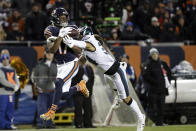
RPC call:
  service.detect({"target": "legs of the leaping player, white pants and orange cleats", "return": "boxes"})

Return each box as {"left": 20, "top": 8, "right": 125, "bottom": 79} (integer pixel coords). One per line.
{"left": 40, "top": 61, "right": 89, "bottom": 120}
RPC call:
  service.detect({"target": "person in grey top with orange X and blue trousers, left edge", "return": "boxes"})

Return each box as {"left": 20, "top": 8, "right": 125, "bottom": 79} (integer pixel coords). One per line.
{"left": 0, "top": 53, "right": 20, "bottom": 130}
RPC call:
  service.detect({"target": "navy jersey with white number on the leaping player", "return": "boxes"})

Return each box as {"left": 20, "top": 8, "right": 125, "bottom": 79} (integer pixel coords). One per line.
{"left": 44, "top": 25, "right": 76, "bottom": 64}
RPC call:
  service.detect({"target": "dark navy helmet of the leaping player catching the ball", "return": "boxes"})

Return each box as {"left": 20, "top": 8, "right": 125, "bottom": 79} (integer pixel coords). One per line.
{"left": 51, "top": 8, "right": 69, "bottom": 27}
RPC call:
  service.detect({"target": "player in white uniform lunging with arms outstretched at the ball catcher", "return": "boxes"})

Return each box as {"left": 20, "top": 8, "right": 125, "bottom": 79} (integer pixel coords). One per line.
{"left": 63, "top": 27, "right": 145, "bottom": 131}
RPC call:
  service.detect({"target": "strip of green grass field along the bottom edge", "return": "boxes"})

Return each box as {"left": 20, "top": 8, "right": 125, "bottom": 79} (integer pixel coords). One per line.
{"left": 18, "top": 125, "right": 196, "bottom": 131}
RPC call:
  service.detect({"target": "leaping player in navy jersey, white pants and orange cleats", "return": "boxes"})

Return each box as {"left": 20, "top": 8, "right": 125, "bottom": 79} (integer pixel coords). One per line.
{"left": 40, "top": 8, "right": 89, "bottom": 120}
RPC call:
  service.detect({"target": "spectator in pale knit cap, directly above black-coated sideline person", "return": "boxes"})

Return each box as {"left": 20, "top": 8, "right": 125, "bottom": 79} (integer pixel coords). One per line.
{"left": 145, "top": 16, "right": 161, "bottom": 41}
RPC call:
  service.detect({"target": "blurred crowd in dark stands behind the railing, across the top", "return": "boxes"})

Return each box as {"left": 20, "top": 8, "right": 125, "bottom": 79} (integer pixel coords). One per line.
{"left": 0, "top": 0, "right": 196, "bottom": 42}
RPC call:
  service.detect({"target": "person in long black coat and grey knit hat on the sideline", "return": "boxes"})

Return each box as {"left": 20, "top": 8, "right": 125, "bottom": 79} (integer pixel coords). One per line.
{"left": 142, "top": 48, "right": 171, "bottom": 126}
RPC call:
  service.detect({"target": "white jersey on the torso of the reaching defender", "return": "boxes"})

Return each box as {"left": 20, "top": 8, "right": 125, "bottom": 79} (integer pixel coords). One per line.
{"left": 82, "top": 35, "right": 115, "bottom": 71}
